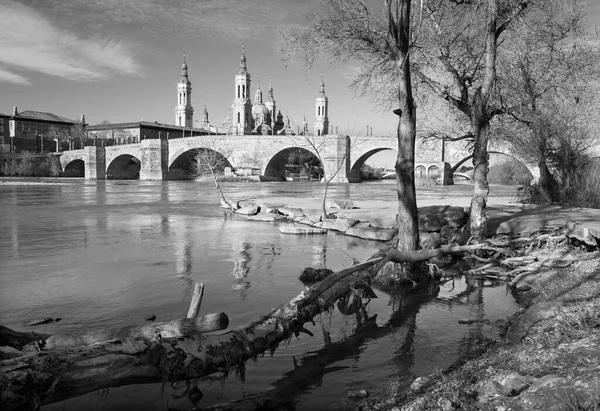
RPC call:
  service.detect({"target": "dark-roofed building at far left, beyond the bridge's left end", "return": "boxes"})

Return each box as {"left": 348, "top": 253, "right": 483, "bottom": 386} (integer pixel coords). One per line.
{"left": 0, "top": 107, "right": 87, "bottom": 153}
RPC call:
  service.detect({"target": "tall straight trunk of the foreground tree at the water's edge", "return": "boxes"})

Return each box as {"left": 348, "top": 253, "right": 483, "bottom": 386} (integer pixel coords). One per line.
{"left": 395, "top": 0, "right": 419, "bottom": 251}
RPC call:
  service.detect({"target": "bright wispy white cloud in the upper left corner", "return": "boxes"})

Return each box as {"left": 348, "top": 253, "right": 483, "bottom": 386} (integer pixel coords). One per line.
{"left": 0, "top": 1, "right": 139, "bottom": 84}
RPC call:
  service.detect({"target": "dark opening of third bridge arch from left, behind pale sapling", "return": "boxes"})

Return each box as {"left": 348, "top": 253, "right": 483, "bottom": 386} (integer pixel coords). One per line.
{"left": 169, "top": 147, "right": 233, "bottom": 180}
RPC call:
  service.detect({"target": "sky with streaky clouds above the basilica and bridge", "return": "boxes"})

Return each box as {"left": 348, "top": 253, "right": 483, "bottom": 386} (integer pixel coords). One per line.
{"left": 0, "top": 0, "right": 600, "bottom": 142}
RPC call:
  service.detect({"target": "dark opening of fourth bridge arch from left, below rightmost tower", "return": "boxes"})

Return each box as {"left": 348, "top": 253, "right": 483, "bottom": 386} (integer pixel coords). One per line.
{"left": 261, "top": 147, "right": 324, "bottom": 181}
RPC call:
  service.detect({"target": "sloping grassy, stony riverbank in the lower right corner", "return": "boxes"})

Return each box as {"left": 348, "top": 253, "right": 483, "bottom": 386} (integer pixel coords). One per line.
{"left": 358, "top": 246, "right": 600, "bottom": 411}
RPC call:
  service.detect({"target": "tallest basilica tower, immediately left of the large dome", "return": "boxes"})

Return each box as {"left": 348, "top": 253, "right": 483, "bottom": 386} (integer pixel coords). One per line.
{"left": 231, "top": 45, "right": 254, "bottom": 134}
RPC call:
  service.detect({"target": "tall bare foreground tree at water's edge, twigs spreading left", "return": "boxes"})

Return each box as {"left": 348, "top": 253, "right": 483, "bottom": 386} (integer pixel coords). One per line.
{"left": 283, "top": 0, "right": 419, "bottom": 250}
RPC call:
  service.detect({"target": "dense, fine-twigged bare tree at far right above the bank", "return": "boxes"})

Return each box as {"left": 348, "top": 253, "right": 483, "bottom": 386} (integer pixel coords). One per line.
{"left": 499, "top": 0, "right": 600, "bottom": 201}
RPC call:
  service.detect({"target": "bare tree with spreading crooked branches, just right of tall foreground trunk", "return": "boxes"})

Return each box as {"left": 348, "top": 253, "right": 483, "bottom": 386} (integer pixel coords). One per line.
{"left": 417, "top": 0, "right": 535, "bottom": 238}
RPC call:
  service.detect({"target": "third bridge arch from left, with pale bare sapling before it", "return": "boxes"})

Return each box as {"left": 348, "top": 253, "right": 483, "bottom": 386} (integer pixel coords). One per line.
{"left": 169, "top": 147, "right": 232, "bottom": 180}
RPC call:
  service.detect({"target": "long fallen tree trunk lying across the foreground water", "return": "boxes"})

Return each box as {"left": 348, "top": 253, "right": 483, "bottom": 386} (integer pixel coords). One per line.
{"left": 0, "top": 244, "right": 536, "bottom": 410}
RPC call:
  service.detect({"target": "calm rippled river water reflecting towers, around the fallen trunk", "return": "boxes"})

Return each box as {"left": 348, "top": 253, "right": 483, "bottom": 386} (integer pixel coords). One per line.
{"left": 0, "top": 180, "right": 517, "bottom": 411}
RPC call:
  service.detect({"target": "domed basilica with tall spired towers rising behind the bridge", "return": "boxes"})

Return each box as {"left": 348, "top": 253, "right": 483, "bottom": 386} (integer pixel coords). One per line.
{"left": 175, "top": 46, "right": 329, "bottom": 135}
